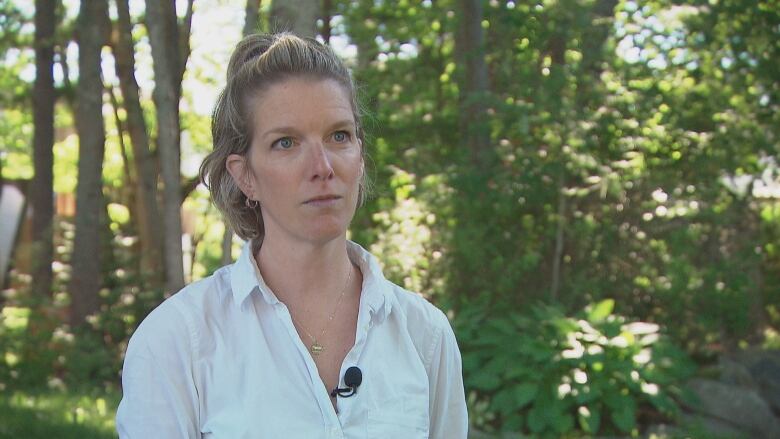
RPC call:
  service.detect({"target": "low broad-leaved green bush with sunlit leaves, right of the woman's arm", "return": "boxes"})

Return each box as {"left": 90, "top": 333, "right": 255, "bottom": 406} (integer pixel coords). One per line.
{"left": 455, "top": 299, "right": 694, "bottom": 436}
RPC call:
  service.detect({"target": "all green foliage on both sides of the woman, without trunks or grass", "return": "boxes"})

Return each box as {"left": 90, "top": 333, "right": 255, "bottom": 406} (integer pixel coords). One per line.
{"left": 0, "top": 0, "right": 780, "bottom": 436}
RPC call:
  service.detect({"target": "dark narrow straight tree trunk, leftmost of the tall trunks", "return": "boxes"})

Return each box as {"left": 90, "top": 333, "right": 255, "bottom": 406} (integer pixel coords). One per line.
{"left": 30, "top": 0, "right": 56, "bottom": 296}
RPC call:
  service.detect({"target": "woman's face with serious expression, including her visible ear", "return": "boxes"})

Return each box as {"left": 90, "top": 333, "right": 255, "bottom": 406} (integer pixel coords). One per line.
{"left": 227, "top": 78, "right": 363, "bottom": 243}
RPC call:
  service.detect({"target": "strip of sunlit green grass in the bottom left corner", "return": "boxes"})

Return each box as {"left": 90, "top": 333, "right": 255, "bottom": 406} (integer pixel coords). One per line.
{"left": 0, "top": 391, "right": 120, "bottom": 439}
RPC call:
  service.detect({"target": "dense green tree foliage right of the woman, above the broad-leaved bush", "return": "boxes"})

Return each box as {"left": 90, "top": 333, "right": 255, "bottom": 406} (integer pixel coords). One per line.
{"left": 337, "top": 1, "right": 780, "bottom": 361}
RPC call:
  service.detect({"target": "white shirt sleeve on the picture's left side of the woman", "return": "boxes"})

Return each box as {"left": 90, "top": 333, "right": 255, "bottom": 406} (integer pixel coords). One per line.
{"left": 116, "top": 296, "right": 200, "bottom": 439}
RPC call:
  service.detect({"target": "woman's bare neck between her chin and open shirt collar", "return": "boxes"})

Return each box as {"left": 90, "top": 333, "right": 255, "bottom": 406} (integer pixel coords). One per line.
{"left": 255, "top": 235, "right": 352, "bottom": 308}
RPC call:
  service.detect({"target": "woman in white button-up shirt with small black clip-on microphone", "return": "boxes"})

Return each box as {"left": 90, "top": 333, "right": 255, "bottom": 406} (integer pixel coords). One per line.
{"left": 117, "top": 33, "right": 468, "bottom": 439}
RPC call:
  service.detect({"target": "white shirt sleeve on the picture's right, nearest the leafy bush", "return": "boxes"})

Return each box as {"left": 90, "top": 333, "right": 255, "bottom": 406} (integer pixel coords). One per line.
{"left": 428, "top": 312, "right": 469, "bottom": 439}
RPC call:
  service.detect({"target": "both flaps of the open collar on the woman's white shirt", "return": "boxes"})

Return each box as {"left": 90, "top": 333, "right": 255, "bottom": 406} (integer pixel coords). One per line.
{"left": 230, "top": 241, "right": 392, "bottom": 321}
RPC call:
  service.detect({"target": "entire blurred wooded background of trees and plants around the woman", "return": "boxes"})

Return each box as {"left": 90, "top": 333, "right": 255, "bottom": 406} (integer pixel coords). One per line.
{"left": 0, "top": 0, "right": 780, "bottom": 438}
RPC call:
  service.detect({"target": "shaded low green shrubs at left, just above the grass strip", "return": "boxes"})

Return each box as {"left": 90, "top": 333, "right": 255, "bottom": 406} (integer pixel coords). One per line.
{"left": 0, "top": 219, "right": 164, "bottom": 390}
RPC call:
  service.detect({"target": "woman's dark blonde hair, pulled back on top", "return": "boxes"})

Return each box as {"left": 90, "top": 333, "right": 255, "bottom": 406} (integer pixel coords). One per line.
{"left": 199, "top": 32, "right": 368, "bottom": 240}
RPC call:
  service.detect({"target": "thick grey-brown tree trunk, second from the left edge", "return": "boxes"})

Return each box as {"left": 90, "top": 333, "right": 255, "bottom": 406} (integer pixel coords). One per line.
{"left": 70, "top": 0, "right": 108, "bottom": 327}
